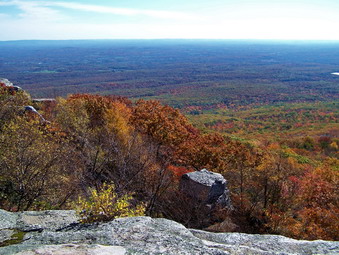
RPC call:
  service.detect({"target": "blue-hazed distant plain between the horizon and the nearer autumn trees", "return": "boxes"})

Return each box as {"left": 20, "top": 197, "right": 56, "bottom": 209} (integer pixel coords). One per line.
{"left": 0, "top": 40, "right": 339, "bottom": 109}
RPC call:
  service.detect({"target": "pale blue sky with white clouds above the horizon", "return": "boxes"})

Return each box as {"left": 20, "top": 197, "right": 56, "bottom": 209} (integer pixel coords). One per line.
{"left": 0, "top": 0, "right": 339, "bottom": 41}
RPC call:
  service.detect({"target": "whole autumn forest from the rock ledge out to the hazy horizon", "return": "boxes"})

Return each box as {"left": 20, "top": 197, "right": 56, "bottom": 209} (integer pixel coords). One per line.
{"left": 0, "top": 41, "right": 339, "bottom": 240}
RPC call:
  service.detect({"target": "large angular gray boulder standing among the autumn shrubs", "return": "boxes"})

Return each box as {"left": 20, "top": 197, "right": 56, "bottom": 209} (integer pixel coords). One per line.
{"left": 180, "top": 169, "right": 232, "bottom": 208}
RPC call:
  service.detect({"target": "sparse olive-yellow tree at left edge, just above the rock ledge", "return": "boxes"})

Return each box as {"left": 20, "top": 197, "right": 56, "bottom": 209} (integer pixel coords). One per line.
{"left": 0, "top": 117, "right": 68, "bottom": 211}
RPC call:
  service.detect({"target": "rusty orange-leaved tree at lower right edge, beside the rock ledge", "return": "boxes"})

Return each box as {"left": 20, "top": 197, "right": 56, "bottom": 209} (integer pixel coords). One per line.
{"left": 287, "top": 160, "right": 339, "bottom": 240}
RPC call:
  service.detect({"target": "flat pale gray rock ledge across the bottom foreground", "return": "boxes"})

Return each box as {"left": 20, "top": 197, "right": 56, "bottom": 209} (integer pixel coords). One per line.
{"left": 0, "top": 210, "right": 339, "bottom": 255}
